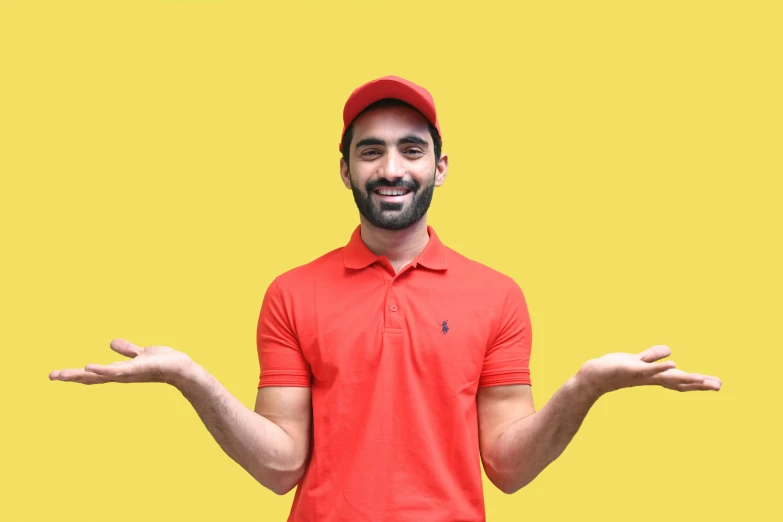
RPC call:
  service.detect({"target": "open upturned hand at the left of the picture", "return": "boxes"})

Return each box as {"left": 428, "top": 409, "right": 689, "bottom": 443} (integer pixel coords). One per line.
{"left": 49, "top": 339, "right": 193, "bottom": 386}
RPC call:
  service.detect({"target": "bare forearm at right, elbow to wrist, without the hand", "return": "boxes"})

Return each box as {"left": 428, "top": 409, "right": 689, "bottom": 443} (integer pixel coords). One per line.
{"left": 484, "top": 374, "right": 600, "bottom": 493}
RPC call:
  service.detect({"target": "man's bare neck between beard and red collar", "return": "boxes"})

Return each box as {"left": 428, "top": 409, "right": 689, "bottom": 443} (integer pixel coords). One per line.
{"left": 361, "top": 215, "right": 430, "bottom": 271}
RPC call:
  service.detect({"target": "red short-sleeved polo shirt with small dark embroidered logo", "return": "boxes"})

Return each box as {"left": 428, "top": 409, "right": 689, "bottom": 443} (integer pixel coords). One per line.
{"left": 257, "top": 227, "right": 531, "bottom": 522}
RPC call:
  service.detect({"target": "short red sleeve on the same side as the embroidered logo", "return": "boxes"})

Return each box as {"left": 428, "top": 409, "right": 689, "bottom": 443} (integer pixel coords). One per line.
{"left": 479, "top": 282, "right": 532, "bottom": 386}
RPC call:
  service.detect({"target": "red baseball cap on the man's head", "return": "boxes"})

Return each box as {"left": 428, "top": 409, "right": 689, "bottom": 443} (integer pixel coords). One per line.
{"left": 339, "top": 76, "right": 441, "bottom": 151}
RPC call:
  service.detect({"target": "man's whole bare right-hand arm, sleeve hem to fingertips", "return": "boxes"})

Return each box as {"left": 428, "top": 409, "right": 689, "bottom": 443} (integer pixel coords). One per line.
{"left": 477, "top": 346, "right": 721, "bottom": 494}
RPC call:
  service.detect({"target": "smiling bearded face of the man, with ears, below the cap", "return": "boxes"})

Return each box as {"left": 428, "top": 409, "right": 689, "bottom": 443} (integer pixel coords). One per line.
{"left": 340, "top": 106, "right": 448, "bottom": 230}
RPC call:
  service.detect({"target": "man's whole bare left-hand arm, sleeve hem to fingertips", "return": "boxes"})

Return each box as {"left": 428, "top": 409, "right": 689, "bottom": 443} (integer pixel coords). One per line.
{"left": 49, "top": 340, "right": 312, "bottom": 495}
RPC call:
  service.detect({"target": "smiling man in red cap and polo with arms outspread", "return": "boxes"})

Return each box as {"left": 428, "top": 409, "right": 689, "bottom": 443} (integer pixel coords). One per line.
{"left": 50, "top": 77, "right": 721, "bottom": 522}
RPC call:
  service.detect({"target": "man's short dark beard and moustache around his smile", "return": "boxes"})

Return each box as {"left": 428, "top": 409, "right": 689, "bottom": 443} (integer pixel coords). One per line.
{"left": 351, "top": 173, "right": 435, "bottom": 230}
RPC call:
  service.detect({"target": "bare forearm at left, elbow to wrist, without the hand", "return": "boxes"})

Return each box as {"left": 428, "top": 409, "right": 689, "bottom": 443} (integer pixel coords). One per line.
{"left": 171, "top": 363, "right": 307, "bottom": 494}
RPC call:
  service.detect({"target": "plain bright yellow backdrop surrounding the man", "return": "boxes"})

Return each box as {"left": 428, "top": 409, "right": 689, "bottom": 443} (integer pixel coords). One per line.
{"left": 0, "top": 0, "right": 783, "bottom": 522}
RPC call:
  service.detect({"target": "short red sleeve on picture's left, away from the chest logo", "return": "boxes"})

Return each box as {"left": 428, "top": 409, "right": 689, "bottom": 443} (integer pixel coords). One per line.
{"left": 256, "top": 280, "right": 311, "bottom": 388}
